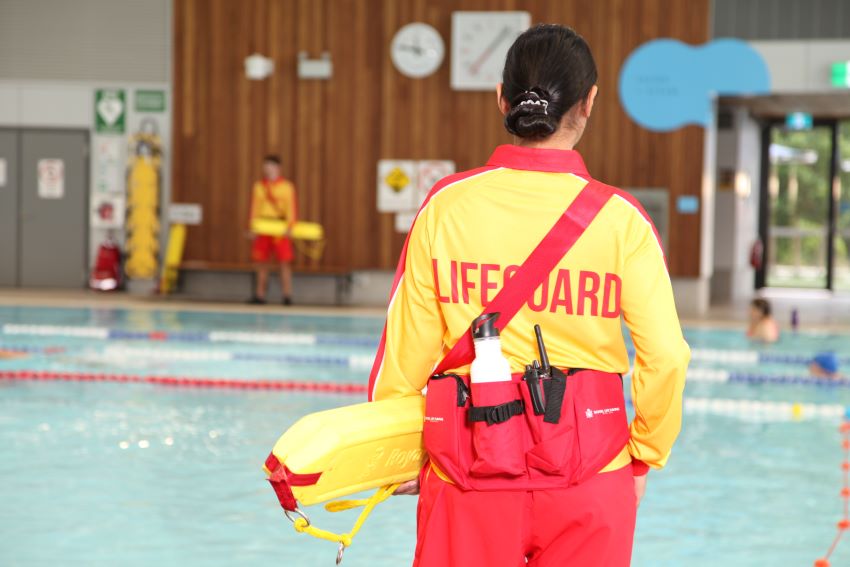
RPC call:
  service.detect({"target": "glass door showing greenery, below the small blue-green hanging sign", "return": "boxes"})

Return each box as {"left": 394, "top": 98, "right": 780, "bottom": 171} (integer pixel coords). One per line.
{"left": 762, "top": 124, "right": 828, "bottom": 288}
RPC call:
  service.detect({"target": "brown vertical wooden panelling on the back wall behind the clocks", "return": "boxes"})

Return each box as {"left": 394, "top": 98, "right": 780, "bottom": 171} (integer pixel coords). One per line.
{"left": 172, "top": 0, "right": 709, "bottom": 276}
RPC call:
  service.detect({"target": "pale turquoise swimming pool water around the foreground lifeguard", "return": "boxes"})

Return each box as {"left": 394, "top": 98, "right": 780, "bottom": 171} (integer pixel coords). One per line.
{"left": 0, "top": 307, "right": 850, "bottom": 567}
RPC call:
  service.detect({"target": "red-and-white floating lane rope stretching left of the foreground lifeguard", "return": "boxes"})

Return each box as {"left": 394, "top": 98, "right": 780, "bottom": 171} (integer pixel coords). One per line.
{"left": 0, "top": 370, "right": 367, "bottom": 394}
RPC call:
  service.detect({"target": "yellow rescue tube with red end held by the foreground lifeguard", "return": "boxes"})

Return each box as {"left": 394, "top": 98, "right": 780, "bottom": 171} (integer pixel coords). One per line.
{"left": 264, "top": 395, "right": 425, "bottom": 510}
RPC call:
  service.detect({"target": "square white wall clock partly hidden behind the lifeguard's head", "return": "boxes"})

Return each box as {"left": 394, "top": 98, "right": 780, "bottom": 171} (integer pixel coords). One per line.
{"left": 452, "top": 12, "right": 531, "bottom": 91}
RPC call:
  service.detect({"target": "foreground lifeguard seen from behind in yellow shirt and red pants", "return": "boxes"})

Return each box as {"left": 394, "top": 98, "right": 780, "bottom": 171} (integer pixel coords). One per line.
{"left": 370, "top": 25, "right": 690, "bottom": 567}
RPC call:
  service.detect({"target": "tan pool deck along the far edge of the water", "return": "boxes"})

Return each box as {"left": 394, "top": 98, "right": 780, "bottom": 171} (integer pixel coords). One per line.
{"left": 0, "top": 288, "right": 850, "bottom": 333}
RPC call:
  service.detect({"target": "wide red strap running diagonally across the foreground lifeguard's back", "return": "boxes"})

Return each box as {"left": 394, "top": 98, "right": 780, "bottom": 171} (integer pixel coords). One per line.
{"left": 434, "top": 180, "right": 612, "bottom": 374}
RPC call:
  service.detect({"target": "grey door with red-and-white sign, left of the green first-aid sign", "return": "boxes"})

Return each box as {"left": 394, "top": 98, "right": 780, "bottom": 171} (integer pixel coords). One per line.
{"left": 19, "top": 130, "right": 89, "bottom": 288}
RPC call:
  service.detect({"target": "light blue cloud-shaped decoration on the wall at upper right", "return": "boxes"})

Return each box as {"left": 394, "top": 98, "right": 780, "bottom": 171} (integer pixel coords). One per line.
{"left": 619, "top": 39, "right": 770, "bottom": 132}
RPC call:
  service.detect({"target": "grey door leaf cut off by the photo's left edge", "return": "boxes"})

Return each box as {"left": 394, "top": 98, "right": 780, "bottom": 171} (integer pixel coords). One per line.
{"left": 0, "top": 130, "right": 18, "bottom": 287}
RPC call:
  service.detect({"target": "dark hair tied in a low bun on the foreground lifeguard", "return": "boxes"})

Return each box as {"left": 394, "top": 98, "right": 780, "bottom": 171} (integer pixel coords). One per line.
{"left": 502, "top": 24, "right": 597, "bottom": 139}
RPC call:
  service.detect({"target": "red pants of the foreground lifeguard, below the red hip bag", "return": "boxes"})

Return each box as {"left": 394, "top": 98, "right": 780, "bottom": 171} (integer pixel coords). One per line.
{"left": 413, "top": 465, "right": 636, "bottom": 567}
